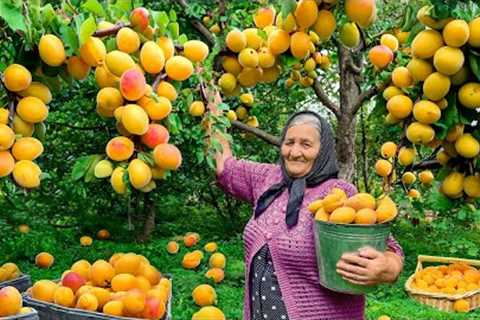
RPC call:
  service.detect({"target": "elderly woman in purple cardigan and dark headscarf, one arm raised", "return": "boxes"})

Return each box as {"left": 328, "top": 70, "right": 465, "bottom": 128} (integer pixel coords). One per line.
{"left": 216, "top": 111, "right": 403, "bottom": 320}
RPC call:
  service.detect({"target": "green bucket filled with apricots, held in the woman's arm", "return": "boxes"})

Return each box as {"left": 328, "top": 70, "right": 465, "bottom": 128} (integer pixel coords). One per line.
{"left": 308, "top": 188, "right": 398, "bottom": 294}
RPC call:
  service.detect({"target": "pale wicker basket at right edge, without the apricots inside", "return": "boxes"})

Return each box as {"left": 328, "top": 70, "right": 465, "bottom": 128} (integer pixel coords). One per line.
{"left": 405, "top": 255, "right": 480, "bottom": 311}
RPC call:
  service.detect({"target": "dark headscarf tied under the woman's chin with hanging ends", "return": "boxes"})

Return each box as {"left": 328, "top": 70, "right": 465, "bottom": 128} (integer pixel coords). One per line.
{"left": 255, "top": 111, "right": 338, "bottom": 228}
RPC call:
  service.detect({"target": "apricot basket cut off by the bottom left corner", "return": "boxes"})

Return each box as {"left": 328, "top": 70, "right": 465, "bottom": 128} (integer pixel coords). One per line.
{"left": 0, "top": 286, "right": 39, "bottom": 320}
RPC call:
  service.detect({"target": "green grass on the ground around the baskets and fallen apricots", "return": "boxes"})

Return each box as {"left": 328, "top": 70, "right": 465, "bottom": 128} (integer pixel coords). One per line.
{"left": 0, "top": 225, "right": 480, "bottom": 320}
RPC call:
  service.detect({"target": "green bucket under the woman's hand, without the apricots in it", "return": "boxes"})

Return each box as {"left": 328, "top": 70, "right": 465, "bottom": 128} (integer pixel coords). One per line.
{"left": 314, "top": 221, "right": 390, "bottom": 294}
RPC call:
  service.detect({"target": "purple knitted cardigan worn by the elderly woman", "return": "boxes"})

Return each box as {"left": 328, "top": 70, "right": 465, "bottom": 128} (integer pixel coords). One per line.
{"left": 217, "top": 157, "right": 403, "bottom": 320}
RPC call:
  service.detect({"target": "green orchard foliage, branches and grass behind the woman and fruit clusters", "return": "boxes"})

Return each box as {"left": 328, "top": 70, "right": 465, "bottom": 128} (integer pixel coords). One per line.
{"left": 0, "top": 0, "right": 480, "bottom": 319}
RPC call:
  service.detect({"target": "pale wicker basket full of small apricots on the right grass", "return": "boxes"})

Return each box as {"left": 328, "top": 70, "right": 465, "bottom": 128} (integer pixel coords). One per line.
{"left": 405, "top": 255, "right": 480, "bottom": 312}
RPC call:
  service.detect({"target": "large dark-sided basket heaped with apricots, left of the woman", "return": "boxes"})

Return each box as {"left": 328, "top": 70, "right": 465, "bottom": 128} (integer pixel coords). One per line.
{"left": 24, "top": 253, "right": 172, "bottom": 320}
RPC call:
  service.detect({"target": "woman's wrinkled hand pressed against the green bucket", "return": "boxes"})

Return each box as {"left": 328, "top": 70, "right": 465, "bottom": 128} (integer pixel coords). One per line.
{"left": 337, "top": 247, "right": 401, "bottom": 286}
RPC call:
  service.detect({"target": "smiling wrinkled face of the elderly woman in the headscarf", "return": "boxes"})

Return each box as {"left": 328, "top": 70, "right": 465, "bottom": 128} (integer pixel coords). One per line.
{"left": 281, "top": 124, "right": 320, "bottom": 178}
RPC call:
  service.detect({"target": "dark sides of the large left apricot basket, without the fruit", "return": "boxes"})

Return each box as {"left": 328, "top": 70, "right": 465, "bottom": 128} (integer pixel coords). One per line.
{"left": 23, "top": 275, "right": 173, "bottom": 320}
